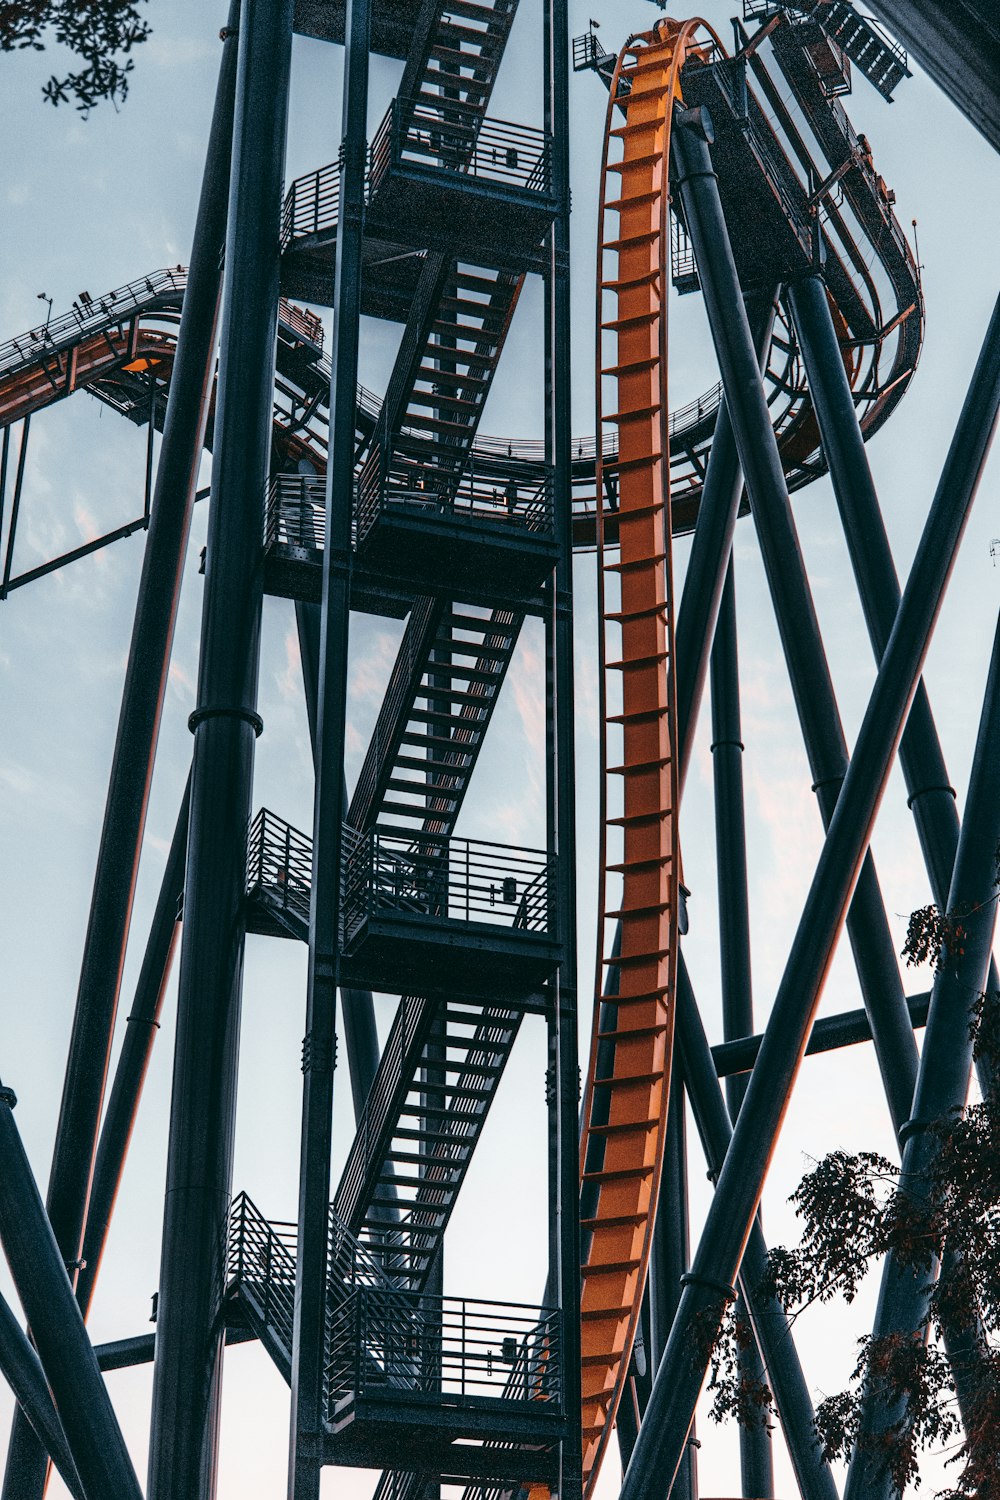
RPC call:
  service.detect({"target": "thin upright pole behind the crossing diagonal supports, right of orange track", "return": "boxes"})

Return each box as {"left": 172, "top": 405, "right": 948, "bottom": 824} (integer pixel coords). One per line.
{"left": 711, "top": 555, "right": 774, "bottom": 1500}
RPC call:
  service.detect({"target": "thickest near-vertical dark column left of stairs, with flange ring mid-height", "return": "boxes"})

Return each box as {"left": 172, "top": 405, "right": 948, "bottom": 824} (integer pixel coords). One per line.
{"left": 148, "top": 0, "right": 292, "bottom": 1500}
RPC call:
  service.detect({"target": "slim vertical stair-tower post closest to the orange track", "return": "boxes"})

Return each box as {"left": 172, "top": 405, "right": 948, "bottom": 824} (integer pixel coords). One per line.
{"left": 543, "top": 0, "right": 582, "bottom": 1500}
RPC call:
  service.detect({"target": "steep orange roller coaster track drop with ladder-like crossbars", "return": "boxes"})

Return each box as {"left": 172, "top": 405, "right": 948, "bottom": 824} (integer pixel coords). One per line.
{"left": 580, "top": 21, "right": 714, "bottom": 1494}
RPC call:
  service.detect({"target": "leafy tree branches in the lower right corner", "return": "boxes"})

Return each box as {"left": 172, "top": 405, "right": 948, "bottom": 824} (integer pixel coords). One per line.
{"left": 711, "top": 1002, "right": 1000, "bottom": 1500}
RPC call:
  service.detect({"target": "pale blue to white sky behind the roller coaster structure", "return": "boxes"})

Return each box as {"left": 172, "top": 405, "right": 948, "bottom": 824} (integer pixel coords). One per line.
{"left": 0, "top": 0, "right": 1000, "bottom": 1500}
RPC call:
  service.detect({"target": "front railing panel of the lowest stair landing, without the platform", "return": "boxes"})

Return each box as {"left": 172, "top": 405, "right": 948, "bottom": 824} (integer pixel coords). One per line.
{"left": 327, "top": 1287, "right": 562, "bottom": 1410}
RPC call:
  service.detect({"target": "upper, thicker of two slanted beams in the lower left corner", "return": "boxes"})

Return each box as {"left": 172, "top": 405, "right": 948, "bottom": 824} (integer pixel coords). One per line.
{"left": 0, "top": 1086, "right": 142, "bottom": 1500}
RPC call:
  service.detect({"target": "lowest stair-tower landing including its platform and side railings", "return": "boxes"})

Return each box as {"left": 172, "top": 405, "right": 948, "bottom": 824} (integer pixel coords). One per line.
{"left": 226, "top": 1194, "right": 565, "bottom": 1484}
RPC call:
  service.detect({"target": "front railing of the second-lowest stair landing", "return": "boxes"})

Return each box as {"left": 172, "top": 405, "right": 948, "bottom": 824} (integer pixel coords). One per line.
{"left": 343, "top": 828, "right": 552, "bottom": 944}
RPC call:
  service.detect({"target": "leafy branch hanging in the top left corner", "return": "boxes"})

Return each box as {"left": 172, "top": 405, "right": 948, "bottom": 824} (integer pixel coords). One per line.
{"left": 0, "top": 0, "right": 150, "bottom": 117}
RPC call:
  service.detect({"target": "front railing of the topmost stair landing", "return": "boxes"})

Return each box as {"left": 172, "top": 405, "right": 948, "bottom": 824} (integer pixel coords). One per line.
{"left": 369, "top": 99, "right": 552, "bottom": 197}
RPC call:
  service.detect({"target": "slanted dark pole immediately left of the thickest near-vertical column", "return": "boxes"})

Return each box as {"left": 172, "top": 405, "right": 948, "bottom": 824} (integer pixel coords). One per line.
{"left": 3, "top": 14, "right": 238, "bottom": 1500}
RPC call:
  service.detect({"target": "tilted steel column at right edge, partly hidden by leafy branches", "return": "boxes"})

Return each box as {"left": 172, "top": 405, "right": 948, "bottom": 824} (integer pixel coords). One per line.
{"left": 844, "top": 609, "right": 1000, "bottom": 1500}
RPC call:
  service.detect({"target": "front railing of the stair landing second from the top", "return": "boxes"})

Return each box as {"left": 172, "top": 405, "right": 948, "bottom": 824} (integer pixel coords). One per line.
{"left": 355, "top": 446, "right": 553, "bottom": 546}
